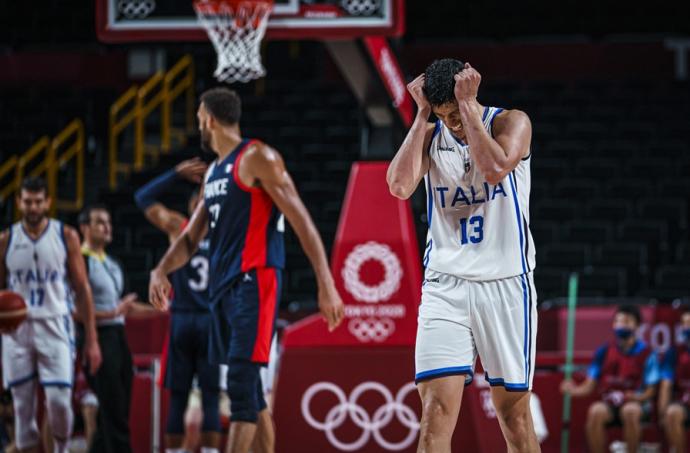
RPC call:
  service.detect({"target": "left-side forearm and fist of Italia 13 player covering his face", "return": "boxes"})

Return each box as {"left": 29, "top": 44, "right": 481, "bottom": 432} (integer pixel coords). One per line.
{"left": 386, "top": 74, "right": 434, "bottom": 200}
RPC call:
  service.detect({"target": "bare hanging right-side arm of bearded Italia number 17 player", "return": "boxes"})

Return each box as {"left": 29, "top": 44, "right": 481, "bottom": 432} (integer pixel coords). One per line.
{"left": 64, "top": 226, "right": 102, "bottom": 374}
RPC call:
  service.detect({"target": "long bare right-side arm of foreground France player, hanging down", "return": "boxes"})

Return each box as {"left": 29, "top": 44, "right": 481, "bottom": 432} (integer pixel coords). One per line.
{"left": 239, "top": 144, "right": 344, "bottom": 330}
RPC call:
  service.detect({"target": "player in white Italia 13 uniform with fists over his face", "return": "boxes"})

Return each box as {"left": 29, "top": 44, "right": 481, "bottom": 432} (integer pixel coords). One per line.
{"left": 387, "top": 59, "right": 539, "bottom": 452}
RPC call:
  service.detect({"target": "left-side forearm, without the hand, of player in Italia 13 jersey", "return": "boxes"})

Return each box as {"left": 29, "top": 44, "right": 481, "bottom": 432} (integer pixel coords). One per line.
{"left": 386, "top": 110, "right": 429, "bottom": 199}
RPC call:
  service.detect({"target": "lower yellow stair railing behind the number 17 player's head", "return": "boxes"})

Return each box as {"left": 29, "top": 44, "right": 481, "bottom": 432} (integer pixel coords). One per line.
{"left": 0, "top": 119, "right": 85, "bottom": 218}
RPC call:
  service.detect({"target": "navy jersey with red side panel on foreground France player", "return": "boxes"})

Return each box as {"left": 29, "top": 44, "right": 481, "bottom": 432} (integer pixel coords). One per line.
{"left": 204, "top": 140, "right": 285, "bottom": 300}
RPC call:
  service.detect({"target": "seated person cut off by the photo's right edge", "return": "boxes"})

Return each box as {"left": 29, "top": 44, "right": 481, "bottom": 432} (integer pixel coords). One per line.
{"left": 659, "top": 307, "right": 690, "bottom": 452}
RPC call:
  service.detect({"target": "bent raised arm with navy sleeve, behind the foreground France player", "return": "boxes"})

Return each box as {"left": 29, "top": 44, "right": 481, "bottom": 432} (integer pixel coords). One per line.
{"left": 134, "top": 158, "right": 206, "bottom": 241}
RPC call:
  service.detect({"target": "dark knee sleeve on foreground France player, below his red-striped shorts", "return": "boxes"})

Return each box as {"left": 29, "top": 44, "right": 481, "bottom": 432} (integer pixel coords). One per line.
{"left": 228, "top": 360, "right": 265, "bottom": 423}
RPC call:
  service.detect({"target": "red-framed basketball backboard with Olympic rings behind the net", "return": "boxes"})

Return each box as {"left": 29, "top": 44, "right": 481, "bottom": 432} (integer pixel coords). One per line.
{"left": 96, "top": 0, "right": 404, "bottom": 43}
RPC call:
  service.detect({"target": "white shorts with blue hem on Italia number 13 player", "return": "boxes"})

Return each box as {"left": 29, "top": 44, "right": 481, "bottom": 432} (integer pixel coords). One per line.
{"left": 415, "top": 269, "right": 537, "bottom": 392}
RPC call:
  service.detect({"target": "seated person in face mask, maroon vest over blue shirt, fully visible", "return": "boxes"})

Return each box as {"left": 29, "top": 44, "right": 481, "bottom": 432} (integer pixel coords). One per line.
{"left": 561, "top": 305, "right": 659, "bottom": 453}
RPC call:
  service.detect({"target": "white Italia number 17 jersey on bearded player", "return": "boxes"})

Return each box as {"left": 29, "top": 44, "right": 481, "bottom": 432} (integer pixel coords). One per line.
{"left": 5, "top": 219, "right": 69, "bottom": 318}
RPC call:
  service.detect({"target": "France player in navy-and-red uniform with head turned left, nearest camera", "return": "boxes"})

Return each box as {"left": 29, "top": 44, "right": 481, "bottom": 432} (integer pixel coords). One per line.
{"left": 149, "top": 88, "right": 344, "bottom": 453}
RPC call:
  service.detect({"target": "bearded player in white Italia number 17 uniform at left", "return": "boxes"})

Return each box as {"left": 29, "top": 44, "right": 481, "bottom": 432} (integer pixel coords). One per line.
{"left": 0, "top": 178, "right": 101, "bottom": 453}
